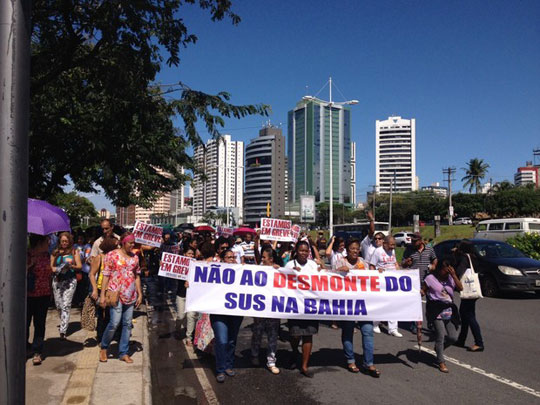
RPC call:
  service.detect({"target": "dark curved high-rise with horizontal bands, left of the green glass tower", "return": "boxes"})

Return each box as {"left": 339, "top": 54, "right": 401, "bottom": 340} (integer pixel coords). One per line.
{"left": 244, "top": 125, "right": 287, "bottom": 224}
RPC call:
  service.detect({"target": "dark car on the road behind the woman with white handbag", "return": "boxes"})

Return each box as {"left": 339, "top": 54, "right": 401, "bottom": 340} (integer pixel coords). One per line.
{"left": 433, "top": 239, "right": 540, "bottom": 297}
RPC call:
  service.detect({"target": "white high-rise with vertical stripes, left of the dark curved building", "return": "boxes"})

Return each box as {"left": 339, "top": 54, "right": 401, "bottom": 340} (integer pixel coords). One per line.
{"left": 192, "top": 135, "right": 244, "bottom": 216}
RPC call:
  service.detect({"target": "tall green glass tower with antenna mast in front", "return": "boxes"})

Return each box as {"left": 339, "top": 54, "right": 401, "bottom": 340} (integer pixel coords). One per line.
{"left": 287, "top": 98, "right": 351, "bottom": 204}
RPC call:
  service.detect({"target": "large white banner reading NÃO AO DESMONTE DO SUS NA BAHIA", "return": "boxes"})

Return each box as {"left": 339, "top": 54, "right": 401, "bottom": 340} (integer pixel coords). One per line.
{"left": 186, "top": 261, "right": 422, "bottom": 321}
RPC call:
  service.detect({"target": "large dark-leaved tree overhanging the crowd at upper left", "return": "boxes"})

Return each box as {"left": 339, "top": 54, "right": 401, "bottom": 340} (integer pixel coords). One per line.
{"left": 29, "top": 0, "right": 269, "bottom": 206}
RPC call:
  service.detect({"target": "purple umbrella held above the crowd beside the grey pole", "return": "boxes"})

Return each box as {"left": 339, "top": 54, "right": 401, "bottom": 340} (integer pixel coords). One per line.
{"left": 28, "top": 198, "right": 71, "bottom": 235}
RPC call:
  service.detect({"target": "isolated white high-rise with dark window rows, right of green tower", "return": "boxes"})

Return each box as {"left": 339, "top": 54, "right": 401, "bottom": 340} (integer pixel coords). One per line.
{"left": 375, "top": 117, "right": 418, "bottom": 194}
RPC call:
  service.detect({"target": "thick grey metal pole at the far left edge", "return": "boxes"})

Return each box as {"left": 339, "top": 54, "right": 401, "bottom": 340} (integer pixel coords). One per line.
{"left": 0, "top": 0, "right": 31, "bottom": 405}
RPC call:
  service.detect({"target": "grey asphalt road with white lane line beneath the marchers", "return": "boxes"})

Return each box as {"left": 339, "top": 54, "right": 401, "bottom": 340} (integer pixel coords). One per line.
{"left": 149, "top": 294, "right": 540, "bottom": 404}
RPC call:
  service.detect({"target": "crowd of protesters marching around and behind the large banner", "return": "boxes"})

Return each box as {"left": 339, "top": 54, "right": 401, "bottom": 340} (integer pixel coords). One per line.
{"left": 27, "top": 215, "right": 484, "bottom": 383}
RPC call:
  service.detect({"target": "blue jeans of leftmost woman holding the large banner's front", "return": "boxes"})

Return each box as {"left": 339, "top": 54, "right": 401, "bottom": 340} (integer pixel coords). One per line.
{"left": 210, "top": 315, "right": 243, "bottom": 374}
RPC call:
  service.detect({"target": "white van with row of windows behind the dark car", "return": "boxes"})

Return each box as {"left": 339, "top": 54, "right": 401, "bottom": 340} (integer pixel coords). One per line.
{"left": 474, "top": 218, "right": 540, "bottom": 241}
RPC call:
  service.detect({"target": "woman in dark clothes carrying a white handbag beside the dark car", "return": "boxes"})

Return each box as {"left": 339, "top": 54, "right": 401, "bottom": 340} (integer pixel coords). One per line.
{"left": 455, "top": 239, "right": 484, "bottom": 352}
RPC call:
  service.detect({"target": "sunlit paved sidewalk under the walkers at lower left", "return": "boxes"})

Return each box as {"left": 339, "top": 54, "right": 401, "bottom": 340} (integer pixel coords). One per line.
{"left": 26, "top": 306, "right": 152, "bottom": 405}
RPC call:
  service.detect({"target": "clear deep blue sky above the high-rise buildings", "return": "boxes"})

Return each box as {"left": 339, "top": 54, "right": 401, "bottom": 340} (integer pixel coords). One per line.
{"left": 82, "top": 0, "right": 540, "bottom": 211}
